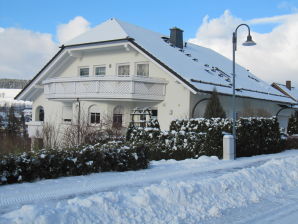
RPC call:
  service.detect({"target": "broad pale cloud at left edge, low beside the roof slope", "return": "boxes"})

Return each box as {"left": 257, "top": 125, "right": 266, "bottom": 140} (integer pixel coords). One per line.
{"left": 0, "top": 28, "right": 58, "bottom": 79}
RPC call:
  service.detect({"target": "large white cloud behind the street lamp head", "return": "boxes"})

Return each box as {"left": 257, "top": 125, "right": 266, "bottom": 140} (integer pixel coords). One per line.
{"left": 190, "top": 11, "right": 298, "bottom": 87}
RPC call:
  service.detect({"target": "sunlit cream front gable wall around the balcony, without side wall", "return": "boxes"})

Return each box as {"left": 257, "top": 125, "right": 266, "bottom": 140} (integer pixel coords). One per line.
{"left": 29, "top": 45, "right": 190, "bottom": 142}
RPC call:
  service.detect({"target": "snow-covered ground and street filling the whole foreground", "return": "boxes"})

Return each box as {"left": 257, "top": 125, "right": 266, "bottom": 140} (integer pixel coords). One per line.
{"left": 0, "top": 150, "right": 298, "bottom": 223}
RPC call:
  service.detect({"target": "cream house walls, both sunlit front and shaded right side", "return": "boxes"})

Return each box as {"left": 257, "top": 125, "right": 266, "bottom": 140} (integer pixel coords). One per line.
{"left": 32, "top": 43, "right": 291, "bottom": 144}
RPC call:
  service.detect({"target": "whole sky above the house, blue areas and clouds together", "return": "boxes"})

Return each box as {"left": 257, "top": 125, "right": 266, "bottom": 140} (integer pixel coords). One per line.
{"left": 0, "top": 0, "right": 298, "bottom": 87}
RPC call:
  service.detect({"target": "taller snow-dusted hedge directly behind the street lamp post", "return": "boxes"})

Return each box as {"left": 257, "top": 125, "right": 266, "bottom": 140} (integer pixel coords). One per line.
{"left": 128, "top": 117, "right": 282, "bottom": 160}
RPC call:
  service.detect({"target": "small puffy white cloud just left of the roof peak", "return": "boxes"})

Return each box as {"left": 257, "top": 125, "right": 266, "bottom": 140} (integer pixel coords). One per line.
{"left": 57, "top": 16, "right": 90, "bottom": 43}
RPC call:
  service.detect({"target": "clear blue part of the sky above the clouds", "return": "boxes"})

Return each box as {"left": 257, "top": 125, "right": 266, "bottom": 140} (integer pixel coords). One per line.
{"left": 0, "top": 0, "right": 298, "bottom": 39}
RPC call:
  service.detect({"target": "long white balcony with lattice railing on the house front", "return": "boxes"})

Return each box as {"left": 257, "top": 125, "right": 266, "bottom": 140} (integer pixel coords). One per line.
{"left": 43, "top": 76, "right": 167, "bottom": 101}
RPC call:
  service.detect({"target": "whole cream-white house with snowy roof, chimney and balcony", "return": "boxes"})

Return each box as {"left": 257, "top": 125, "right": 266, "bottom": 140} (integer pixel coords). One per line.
{"left": 16, "top": 19, "right": 296, "bottom": 143}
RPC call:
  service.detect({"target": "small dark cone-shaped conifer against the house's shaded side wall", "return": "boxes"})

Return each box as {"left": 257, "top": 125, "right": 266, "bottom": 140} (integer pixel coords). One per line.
{"left": 204, "top": 88, "right": 226, "bottom": 118}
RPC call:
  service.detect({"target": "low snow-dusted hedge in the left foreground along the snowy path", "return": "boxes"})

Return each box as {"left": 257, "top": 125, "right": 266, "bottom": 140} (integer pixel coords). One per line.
{"left": 0, "top": 142, "right": 148, "bottom": 184}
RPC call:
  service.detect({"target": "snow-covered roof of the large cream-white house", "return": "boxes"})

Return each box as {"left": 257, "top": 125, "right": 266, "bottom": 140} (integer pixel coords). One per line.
{"left": 65, "top": 19, "right": 294, "bottom": 103}
